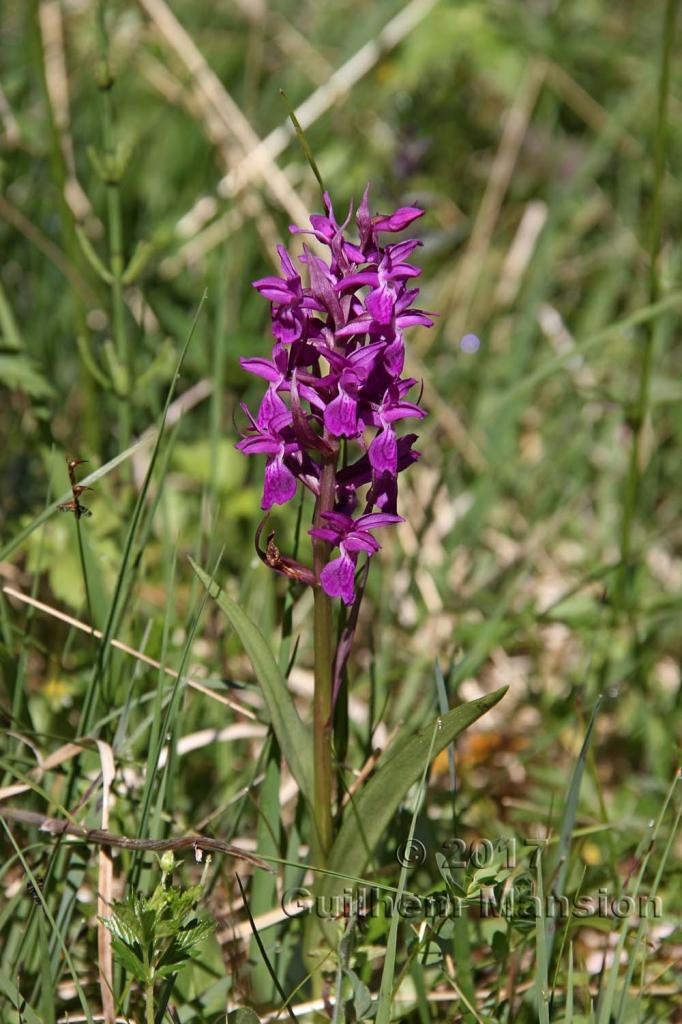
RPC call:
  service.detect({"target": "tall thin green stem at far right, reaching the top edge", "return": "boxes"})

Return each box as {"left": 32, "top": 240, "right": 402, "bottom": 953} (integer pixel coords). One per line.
{"left": 616, "top": 0, "right": 678, "bottom": 608}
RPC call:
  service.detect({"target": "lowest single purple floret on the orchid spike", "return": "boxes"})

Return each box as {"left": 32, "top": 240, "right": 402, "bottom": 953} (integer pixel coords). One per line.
{"left": 308, "top": 512, "right": 402, "bottom": 604}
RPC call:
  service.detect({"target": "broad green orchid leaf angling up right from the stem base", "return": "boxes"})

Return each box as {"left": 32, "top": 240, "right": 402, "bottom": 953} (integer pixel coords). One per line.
{"left": 321, "top": 686, "right": 507, "bottom": 896}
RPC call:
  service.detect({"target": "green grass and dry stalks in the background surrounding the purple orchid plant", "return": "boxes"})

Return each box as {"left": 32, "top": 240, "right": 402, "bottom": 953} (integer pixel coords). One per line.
{"left": 0, "top": 0, "right": 682, "bottom": 1024}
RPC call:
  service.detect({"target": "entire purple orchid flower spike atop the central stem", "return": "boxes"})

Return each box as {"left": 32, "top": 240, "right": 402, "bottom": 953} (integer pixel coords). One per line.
{"left": 237, "top": 186, "right": 433, "bottom": 604}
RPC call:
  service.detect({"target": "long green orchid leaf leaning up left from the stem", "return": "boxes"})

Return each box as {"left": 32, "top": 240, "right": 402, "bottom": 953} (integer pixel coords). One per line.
{"left": 189, "top": 558, "right": 312, "bottom": 805}
